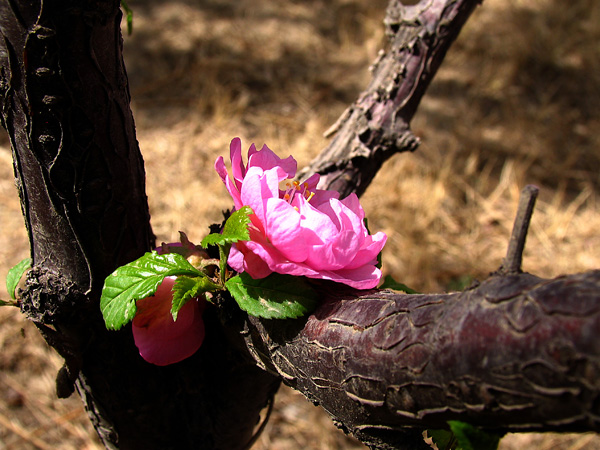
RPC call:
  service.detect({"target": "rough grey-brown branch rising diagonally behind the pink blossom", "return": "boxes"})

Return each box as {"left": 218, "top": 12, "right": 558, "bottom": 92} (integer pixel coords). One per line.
{"left": 300, "top": 0, "right": 480, "bottom": 197}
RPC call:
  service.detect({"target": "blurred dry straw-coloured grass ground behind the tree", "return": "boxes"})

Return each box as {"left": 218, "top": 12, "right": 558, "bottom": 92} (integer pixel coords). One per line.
{"left": 0, "top": 0, "right": 600, "bottom": 450}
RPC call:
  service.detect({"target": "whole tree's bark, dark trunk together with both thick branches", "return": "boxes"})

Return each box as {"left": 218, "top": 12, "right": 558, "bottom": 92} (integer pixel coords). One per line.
{"left": 0, "top": 0, "right": 600, "bottom": 449}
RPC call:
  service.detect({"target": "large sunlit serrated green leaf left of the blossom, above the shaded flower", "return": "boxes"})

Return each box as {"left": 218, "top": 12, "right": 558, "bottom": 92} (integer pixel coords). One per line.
{"left": 100, "top": 251, "right": 202, "bottom": 330}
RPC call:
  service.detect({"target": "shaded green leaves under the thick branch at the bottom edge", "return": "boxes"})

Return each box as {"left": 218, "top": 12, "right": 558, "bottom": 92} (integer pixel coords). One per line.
{"left": 427, "top": 420, "right": 503, "bottom": 450}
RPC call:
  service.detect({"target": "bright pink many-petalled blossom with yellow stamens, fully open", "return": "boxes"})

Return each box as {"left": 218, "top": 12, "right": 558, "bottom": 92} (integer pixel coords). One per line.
{"left": 215, "top": 138, "right": 387, "bottom": 289}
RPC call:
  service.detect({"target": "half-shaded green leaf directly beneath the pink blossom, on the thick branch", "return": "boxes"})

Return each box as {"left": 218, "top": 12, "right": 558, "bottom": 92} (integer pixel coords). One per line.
{"left": 225, "top": 272, "right": 318, "bottom": 319}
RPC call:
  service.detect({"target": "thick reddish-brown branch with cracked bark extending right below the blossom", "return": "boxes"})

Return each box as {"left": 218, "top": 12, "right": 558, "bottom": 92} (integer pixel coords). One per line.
{"left": 247, "top": 271, "right": 600, "bottom": 448}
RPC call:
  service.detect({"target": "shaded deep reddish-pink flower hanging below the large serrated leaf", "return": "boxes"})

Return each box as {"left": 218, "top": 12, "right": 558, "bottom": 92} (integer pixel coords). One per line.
{"left": 132, "top": 277, "right": 205, "bottom": 366}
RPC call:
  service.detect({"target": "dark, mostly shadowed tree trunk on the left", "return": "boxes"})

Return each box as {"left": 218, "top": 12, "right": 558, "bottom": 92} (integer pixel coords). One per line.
{"left": 0, "top": 0, "right": 279, "bottom": 450}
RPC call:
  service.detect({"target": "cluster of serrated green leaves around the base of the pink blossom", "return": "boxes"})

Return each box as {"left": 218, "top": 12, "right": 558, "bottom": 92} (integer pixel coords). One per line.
{"left": 100, "top": 206, "right": 318, "bottom": 330}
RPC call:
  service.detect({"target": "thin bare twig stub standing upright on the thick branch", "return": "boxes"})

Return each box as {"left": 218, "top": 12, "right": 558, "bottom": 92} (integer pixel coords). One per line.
{"left": 499, "top": 184, "right": 539, "bottom": 274}
